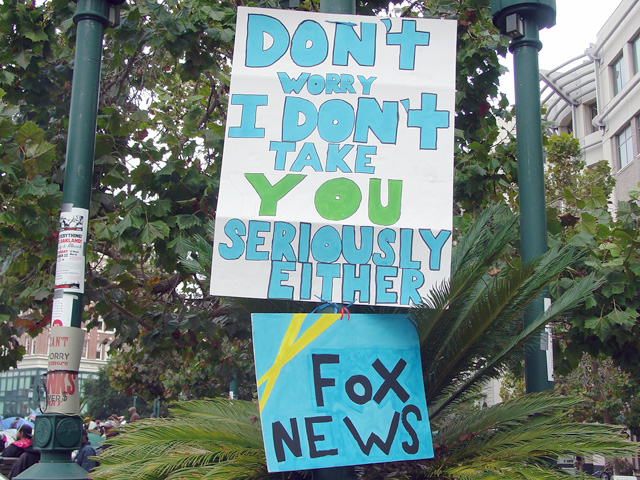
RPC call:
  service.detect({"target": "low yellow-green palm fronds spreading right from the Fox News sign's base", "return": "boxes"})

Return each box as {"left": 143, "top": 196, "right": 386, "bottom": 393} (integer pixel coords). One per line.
{"left": 365, "top": 392, "right": 640, "bottom": 480}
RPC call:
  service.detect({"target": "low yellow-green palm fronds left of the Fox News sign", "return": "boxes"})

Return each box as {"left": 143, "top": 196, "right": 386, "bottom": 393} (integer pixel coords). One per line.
{"left": 93, "top": 399, "right": 267, "bottom": 480}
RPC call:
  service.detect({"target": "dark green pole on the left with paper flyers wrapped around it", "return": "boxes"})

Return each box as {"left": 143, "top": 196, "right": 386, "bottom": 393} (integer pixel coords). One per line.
{"left": 16, "top": 0, "right": 121, "bottom": 480}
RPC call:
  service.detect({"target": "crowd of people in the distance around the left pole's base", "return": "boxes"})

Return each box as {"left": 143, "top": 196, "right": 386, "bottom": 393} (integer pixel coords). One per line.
{"left": 0, "top": 407, "right": 140, "bottom": 480}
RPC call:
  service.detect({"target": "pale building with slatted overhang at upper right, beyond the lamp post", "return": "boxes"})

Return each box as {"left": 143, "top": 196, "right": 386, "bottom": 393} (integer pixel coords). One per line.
{"left": 540, "top": 0, "right": 640, "bottom": 205}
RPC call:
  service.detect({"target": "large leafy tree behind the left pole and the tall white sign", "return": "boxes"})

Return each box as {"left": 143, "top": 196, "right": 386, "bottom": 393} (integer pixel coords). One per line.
{"left": 0, "top": 0, "right": 515, "bottom": 398}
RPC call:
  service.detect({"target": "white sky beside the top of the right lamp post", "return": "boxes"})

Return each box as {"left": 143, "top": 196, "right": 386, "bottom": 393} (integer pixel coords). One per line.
{"left": 500, "top": 0, "right": 621, "bottom": 103}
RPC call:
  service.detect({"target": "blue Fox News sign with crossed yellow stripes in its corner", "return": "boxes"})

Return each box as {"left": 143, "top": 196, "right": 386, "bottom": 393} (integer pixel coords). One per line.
{"left": 252, "top": 313, "right": 433, "bottom": 472}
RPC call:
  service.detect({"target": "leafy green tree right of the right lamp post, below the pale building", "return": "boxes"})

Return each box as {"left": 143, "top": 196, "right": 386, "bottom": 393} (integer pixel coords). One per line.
{"left": 547, "top": 135, "right": 640, "bottom": 382}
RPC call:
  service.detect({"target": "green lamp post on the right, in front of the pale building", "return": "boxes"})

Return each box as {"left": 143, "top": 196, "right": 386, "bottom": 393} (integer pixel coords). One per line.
{"left": 491, "top": 0, "right": 556, "bottom": 392}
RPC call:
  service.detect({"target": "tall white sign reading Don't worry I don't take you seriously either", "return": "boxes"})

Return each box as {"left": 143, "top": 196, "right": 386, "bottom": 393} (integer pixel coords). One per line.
{"left": 211, "top": 7, "right": 456, "bottom": 306}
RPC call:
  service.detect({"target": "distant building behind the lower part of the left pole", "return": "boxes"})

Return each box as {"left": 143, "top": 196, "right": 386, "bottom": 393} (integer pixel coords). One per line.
{"left": 0, "top": 324, "right": 113, "bottom": 417}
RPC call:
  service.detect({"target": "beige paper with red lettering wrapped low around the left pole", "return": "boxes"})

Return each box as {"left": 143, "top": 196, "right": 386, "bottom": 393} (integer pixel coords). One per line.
{"left": 46, "top": 327, "right": 85, "bottom": 415}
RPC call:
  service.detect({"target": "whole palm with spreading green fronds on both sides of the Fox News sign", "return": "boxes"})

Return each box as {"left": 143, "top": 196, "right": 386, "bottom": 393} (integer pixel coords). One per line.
{"left": 92, "top": 206, "right": 638, "bottom": 480}
